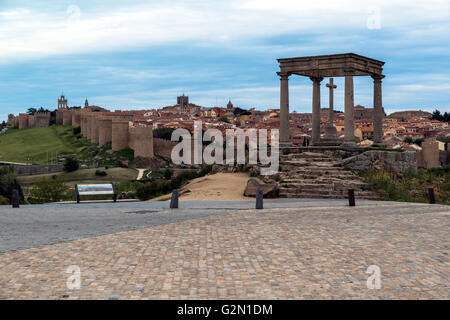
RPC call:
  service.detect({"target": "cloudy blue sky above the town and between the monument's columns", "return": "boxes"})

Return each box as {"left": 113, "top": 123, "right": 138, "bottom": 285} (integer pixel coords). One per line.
{"left": 0, "top": 0, "right": 450, "bottom": 121}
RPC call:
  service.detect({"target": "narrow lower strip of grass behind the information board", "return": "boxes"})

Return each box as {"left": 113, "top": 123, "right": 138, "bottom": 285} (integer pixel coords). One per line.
{"left": 17, "top": 168, "right": 138, "bottom": 186}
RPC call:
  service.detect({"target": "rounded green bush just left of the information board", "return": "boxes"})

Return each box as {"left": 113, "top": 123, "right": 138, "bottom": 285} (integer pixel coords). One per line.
{"left": 30, "top": 176, "right": 70, "bottom": 203}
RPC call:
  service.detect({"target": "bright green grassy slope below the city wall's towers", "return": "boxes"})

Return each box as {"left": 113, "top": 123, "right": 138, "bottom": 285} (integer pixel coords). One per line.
{"left": 0, "top": 126, "right": 91, "bottom": 164}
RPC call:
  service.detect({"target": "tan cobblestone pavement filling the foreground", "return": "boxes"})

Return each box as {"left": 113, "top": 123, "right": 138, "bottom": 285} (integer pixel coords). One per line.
{"left": 0, "top": 202, "right": 450, "bottom": 299}
